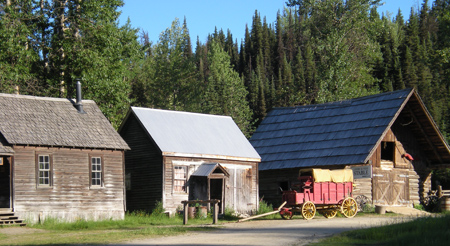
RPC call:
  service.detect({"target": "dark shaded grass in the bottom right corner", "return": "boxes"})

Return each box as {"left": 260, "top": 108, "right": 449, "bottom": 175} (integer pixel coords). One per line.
{"left": 312, "top": 214, "right": 450, "bottom": 246}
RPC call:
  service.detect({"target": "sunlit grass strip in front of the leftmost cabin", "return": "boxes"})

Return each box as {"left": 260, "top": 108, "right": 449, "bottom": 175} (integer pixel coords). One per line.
{"left": 0, "top": 212, "right": 220, "bottom": 245}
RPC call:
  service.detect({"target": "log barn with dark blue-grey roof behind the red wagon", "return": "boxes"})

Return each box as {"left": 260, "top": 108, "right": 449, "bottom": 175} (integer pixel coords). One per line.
{"left": 250, "top": 89, "right": 450, "bottom": 206}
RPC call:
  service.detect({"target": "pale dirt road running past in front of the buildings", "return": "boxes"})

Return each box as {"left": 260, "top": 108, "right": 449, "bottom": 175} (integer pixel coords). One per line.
{"left": 115, "top": 216, "right": 411, "bottom": 246}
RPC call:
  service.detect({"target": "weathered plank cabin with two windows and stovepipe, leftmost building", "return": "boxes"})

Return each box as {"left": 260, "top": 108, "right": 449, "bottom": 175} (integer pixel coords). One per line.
{"left": 0, "top": 90, "right": 129, "bottom": 222}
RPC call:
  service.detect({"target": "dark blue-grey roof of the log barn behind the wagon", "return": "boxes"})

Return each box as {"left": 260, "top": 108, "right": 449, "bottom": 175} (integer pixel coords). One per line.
{"left": 250, "top": 89, "right": 450, "bottom": 170}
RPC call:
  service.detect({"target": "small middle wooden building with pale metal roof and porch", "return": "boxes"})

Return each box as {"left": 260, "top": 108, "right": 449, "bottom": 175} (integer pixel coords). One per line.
{"left": 119, "top": 107, "right": 260, "bottom": 213}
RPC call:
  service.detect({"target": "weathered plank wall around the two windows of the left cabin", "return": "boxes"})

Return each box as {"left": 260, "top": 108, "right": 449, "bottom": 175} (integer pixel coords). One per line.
{"left": 13, "top": 146, "right": 124, "bottom": 220}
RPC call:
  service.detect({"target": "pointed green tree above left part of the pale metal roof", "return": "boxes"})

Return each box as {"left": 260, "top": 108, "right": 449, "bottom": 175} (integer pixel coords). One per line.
{"left": 138, "top": 19, "right": 200, "bottom": 111}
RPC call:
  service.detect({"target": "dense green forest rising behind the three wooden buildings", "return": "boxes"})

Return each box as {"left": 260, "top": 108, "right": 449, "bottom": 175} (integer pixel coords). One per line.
{"left": 0, "top": 0, "right": 450, "bottom": 141}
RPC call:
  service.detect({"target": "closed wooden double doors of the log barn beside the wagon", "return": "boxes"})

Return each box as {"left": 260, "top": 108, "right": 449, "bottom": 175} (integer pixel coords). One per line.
{"left": 372, "top": 169, "right": 409, "bottom": 206}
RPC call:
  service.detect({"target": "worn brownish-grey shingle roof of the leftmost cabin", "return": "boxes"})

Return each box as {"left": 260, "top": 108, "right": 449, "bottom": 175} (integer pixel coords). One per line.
{"left": 0, "top": 93, "right": 129, "bottom": 150}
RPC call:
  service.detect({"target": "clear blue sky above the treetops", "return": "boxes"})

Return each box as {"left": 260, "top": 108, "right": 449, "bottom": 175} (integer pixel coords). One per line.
{"left": 119, "top": 0, "right": 432, "bottom": 45}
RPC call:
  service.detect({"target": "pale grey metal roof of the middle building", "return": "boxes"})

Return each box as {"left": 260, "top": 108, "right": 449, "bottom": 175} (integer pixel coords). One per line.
{"left": 131, "top": 107, "right": 260, "bottom": 161}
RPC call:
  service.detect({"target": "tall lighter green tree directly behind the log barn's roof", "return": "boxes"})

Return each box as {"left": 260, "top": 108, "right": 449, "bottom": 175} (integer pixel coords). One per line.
{"left": 289, "top": 0, "right": 380, "bottom": 102}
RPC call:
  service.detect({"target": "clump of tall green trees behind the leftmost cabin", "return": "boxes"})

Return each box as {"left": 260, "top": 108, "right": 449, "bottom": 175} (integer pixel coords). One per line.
{"left": 0, "top": 0, "right": 141, "bottom": 127}
